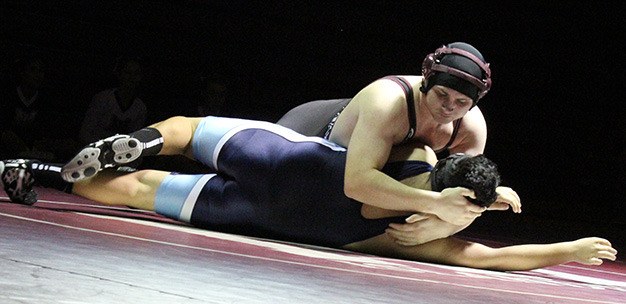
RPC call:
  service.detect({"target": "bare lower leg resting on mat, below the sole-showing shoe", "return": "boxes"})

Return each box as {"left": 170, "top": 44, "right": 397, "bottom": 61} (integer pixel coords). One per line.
{"left": 72, "top": 170, "right": 169, "bottom": 210}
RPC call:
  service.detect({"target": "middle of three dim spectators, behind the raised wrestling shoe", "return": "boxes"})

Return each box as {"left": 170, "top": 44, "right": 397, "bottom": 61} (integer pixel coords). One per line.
{"left": 79, "top": 57, "right": 147, "bottom": 143}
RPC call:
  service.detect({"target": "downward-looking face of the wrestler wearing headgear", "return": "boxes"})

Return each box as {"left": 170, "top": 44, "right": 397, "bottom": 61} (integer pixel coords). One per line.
{"left": 425, "top": 85, "right": 473, "bottom": 124}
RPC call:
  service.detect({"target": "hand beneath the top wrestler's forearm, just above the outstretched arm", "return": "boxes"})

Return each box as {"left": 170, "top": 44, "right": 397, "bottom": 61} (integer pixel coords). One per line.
{"left": 385, "top": 214, "right": 448, "bottom": 246}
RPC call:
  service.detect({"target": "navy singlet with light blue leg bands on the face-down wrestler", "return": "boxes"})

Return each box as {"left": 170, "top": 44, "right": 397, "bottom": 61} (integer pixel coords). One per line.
{"left": 155, "top": 117, "right": 432, "bottom": 247}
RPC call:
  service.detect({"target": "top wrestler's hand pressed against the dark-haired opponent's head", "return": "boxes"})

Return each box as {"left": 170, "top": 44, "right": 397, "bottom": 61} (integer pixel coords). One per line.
{"left": 433, "top": 187, "right": 487, "bottom": 226}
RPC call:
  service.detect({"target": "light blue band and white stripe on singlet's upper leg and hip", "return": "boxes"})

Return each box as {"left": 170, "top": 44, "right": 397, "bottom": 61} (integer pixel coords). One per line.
{"left": 191, "top": 116, "right": 346, "bottom": 170}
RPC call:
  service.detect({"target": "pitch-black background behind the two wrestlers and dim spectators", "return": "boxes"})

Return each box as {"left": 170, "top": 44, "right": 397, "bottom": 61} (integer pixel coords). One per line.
{"left": 0, "top": 0, "right": 626, "bottom": 251}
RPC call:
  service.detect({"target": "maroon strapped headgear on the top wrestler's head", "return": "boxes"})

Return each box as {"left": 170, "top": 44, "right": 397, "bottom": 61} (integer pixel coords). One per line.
{"left": 422, "top": 45, "right": 491, "bottom": 99}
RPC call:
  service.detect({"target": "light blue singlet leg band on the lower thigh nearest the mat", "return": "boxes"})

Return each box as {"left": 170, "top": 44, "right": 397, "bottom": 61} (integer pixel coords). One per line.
{"left": 154, "top": 174, "right": 215, "bottom": 222}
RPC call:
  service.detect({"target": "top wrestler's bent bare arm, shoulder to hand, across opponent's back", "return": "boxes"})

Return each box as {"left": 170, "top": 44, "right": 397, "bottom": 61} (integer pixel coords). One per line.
{"left": 344, "top": 83, "right": 482, "bottom": 225}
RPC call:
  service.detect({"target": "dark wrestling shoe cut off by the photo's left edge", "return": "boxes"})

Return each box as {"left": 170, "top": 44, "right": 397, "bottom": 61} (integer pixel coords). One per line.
{"left": 0, "top": 159, "right": 37, "bottom": 205}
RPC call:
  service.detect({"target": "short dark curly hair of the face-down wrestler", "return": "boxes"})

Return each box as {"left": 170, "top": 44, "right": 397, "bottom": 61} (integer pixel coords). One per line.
{"left": 430, "top": 153, "right": 500, "bottom": 207}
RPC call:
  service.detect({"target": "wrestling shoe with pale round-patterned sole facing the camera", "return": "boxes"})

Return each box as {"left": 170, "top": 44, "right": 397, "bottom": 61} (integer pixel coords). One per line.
{"left": 61, "top": 135, "right": 143, "bottom": 183}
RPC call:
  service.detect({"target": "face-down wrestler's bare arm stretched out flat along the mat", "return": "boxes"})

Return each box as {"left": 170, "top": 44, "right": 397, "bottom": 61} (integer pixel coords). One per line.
{"left": 345, "top": 234, "right": 617, "bottom": 271}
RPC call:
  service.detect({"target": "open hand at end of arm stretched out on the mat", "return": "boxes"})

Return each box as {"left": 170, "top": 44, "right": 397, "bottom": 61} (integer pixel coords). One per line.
{"left": 571, "top": 237, "right": 617, "bottom": 265}
